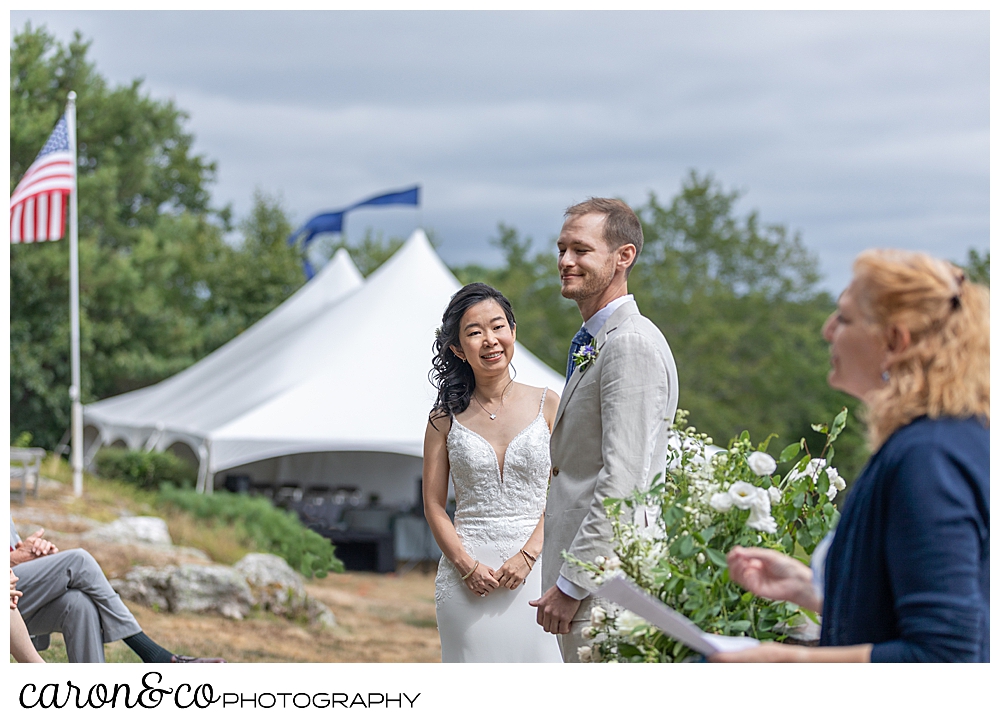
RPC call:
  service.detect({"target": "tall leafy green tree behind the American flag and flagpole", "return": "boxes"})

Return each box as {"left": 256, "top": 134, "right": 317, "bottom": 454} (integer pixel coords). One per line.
{"left": 10, "top": 25, "right": 304, "bottom": 448}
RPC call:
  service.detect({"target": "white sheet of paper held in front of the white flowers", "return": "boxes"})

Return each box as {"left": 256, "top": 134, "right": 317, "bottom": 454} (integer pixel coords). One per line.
{"left": 595, "top": 575, "right": 760, "bottom": 656}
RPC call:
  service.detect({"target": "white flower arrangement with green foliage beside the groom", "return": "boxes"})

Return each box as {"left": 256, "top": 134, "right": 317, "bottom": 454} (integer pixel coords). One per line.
{"left": 569, "top": 409, "right": 847, "bottom": 662}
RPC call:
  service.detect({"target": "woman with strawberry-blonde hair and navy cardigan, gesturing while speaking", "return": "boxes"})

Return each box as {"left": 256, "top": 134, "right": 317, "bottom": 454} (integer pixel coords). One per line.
{"left": 711, "top": 250, "right": 990, "bottom": 662}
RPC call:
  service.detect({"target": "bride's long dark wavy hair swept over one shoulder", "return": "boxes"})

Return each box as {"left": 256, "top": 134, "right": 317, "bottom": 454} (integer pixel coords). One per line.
{"left": 427, "top": 282, "right": 517, "bottom": 424}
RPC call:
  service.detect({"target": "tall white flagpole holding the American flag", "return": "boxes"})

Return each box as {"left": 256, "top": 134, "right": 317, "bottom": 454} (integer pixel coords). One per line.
{"left": 66, "top": 91, "right": 83, "bottom": 497}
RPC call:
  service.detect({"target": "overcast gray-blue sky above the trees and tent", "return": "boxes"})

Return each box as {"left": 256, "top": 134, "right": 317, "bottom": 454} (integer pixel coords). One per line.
{"left": 10, "top": 11, "right": 989, "bottom": 291}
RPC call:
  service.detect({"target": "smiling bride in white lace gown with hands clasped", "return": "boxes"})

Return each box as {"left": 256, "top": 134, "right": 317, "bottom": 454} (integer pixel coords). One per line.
{"left": 423, "top": 283, "right": 562, "bottom": 663}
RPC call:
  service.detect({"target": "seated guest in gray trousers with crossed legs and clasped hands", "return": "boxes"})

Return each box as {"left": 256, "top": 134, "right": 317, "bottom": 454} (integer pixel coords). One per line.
{"left": 10, "top": 519, "right": 226, "bottom": 663}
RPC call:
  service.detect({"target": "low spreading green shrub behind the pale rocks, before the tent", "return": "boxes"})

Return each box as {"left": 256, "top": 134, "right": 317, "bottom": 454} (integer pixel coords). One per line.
{"left": 159, "top": 485, "right": 344, "bottom": 577}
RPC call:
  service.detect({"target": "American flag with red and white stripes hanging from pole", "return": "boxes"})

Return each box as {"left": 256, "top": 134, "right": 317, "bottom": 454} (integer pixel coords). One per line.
{"left": 10, "top": 116, "right": 75, "bottom": 244}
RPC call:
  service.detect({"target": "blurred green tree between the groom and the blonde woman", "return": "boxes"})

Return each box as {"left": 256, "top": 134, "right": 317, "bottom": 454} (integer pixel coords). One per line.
{"left": 629, "top": 172, "right": 867, "bottom": 478}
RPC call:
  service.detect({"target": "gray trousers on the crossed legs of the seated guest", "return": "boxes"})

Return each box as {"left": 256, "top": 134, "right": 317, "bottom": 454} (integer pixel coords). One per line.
{"left": 14, "top": 550, "right": 142, "bottom": 663}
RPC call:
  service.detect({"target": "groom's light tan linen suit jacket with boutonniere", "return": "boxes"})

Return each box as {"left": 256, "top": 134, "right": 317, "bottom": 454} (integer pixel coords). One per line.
{"left": 542, "top": 301, "right": 677, "bottom": 662}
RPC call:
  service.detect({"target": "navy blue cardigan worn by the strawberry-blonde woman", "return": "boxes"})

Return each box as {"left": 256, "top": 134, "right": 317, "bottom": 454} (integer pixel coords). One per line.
{"left": 820, "top": 417, "right": 990, "bottom": 662}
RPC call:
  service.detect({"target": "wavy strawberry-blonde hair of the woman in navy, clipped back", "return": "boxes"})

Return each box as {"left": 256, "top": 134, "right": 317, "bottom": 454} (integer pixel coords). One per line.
{"left": 854, "top": 249, "right": 990, "bottom": 449}
